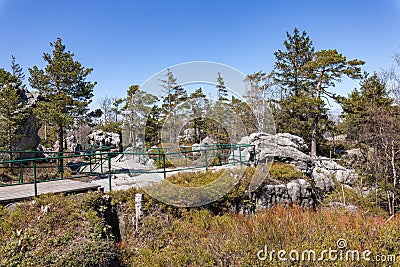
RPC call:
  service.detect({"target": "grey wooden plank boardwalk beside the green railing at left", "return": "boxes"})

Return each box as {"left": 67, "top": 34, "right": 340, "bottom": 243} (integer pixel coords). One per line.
{"left": 0, "top": 179, "right": 100, "bottom": 203}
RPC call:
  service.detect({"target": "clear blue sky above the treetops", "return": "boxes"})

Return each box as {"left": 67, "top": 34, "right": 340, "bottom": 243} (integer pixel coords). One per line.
{"left": 0, "top": 0, "right": 400, "bottom": 112}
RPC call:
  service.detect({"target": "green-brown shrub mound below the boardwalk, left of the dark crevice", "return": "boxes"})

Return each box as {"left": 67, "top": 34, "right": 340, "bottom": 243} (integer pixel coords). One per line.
{"left": 0, "top": 193, "right": 119, "bottom": 267}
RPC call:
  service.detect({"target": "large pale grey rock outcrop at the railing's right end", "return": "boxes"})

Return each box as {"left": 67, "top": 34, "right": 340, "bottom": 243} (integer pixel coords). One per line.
{"left": 230, "top": 133, "right": 358, "bottom": 209}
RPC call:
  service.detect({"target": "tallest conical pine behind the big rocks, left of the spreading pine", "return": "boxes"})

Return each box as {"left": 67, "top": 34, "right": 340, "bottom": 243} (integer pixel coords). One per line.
{"left": 270, "top": 28, "right": 318, "bottom": 147}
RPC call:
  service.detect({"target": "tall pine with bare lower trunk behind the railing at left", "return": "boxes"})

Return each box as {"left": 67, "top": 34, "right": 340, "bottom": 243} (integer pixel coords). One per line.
{"left": 29, "top": 38, "right": 96, "bottom": 176}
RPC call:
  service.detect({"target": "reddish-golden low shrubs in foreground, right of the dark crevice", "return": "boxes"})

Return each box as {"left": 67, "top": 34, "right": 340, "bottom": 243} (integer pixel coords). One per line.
{"left": 120, "top": 202, "right": 400, "bottom": 266}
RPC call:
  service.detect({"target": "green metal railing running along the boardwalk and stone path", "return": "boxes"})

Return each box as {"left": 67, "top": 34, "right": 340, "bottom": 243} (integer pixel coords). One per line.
{"left": 0, "top": 144, "right": 254, "bottom": 196}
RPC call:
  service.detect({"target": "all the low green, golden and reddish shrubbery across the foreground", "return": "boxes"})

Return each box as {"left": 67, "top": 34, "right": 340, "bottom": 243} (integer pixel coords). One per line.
{"left": 0, "top": 168, "right": 400, "bottom": 267}
